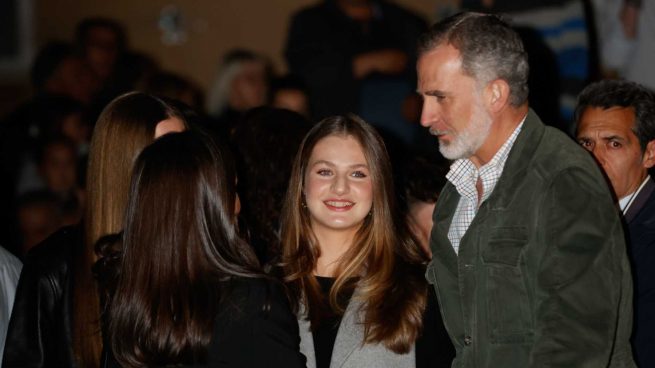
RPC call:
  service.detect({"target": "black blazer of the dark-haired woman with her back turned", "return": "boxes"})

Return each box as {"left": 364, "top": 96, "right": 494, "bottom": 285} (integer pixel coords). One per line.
{"left": 103, "top": 278, "right": 305, "bottom": 368}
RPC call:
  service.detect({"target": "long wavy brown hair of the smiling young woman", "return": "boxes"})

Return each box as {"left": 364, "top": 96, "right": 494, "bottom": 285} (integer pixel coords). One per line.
{"left": 281, "top": 115, "right": 427, "bottom": 353}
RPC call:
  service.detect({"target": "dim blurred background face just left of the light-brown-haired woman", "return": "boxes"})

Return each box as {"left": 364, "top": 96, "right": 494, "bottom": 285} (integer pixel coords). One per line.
{"left": 40, "top": 142, "right": 77, "bottom": 193}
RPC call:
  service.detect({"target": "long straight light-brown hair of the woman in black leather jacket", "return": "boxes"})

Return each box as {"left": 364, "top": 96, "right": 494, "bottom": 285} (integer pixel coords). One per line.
{"left": 72, "top": 92, "right": 185, "bottom": 367}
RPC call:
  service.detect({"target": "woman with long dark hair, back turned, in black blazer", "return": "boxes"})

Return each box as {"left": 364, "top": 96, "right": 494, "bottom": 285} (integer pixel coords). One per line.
{"left": 99, "top": 132, "right": 305, "bottom": 368}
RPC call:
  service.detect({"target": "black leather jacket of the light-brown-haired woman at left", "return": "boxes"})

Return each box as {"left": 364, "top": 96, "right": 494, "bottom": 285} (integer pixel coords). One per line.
{"left": 2, "top": 227, "right": 83, "bottom": 368}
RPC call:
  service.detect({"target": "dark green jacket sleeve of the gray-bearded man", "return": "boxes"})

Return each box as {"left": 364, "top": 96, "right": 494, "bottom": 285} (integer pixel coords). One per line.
{"left": 529, "top": 168, "right": 632, "bottom": 367}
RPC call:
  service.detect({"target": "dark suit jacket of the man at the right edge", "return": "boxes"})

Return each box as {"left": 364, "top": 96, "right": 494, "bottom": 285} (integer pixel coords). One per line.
{"left": 625, "top": 178, "right": 655, "bottom": 367}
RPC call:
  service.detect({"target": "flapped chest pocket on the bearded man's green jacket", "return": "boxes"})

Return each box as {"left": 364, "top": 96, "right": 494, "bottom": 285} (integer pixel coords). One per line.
{"left": 482, "top": 227, "right": 532, "bottom": 343}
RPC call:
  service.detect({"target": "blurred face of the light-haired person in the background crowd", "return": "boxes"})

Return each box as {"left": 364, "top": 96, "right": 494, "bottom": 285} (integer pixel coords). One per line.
{"left": 228, "top": 61, "right": 268, "bottom": 111}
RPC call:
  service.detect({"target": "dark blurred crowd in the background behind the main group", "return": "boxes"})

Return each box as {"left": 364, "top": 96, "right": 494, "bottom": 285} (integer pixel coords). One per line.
{"left": 0, "top": 0, "right": 655, "bottom": 259}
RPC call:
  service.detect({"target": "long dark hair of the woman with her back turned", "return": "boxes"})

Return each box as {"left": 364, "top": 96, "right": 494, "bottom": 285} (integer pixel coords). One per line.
{"left": 108, "top": 132, "right": 260, "bottom": 367}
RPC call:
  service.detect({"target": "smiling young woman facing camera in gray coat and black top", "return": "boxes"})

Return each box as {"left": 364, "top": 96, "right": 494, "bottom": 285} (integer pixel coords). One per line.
{"left": 282, "top": 116, "right": 454, "bottom": 368}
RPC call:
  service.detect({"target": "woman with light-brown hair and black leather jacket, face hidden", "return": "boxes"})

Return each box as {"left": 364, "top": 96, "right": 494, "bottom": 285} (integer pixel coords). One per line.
{"left": 2, "top": 92, "right": 187, "bottom": 368}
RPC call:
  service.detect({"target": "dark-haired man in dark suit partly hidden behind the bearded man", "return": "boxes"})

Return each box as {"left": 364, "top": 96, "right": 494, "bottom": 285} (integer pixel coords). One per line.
{"left": 575, "top": 80, "right": 655, "bottom": 367}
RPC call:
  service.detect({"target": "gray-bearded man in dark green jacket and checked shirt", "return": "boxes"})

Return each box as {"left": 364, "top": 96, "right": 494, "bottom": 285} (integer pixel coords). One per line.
{"left": 417, "top": 13, "right": 634, "bottom": 368}
